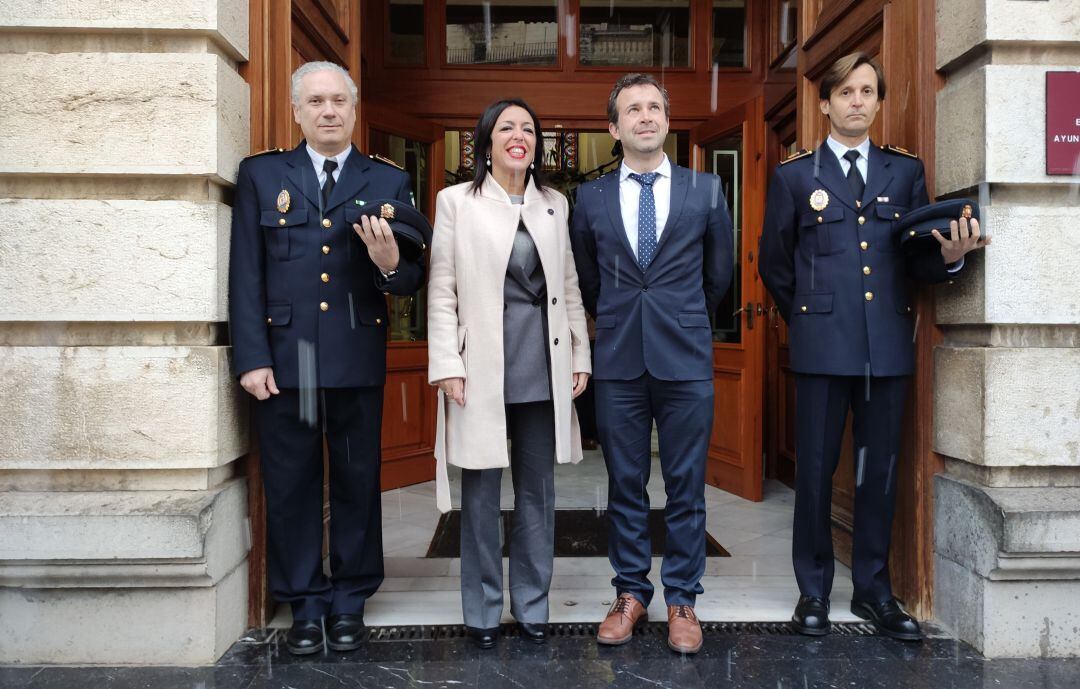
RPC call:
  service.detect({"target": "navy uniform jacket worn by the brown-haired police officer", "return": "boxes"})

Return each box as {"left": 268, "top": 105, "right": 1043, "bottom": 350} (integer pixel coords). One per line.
{"left": 758, "top": 144, "right": 949, "bottom": 376}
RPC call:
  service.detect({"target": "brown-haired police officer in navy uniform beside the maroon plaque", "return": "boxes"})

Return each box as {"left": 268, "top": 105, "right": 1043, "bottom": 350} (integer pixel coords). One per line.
{"left": 759, "top": 53, "right": 984, "bottom": 640}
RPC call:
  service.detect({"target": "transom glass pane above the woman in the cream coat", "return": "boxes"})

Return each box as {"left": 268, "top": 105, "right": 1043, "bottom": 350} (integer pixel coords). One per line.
{"left": 446, "top": 0, "right": 558, "bottom": 65}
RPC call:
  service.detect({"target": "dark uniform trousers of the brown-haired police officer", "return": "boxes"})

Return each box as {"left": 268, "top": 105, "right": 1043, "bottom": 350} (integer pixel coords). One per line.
{"left": 792, "top": 375, "right": 908, "bottom": 602}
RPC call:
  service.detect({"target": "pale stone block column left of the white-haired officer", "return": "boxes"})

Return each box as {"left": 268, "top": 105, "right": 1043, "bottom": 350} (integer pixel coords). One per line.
{"left": 0, "top": 0, "right": 249, "bottom": 664}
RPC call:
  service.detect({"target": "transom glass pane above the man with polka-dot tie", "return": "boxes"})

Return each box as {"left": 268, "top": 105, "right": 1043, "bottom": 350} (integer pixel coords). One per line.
{"left": 578, "top": 0, "right": 690, "bottom": 67}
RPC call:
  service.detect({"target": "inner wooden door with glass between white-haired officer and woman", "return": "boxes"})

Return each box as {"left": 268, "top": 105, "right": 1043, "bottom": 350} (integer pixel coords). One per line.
{"left": 361, "top": 100, "right": 445, "bottom": 490}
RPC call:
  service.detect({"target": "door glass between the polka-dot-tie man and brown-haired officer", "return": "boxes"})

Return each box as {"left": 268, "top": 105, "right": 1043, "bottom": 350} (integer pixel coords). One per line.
{"left": 704, "top": 133, "right": 743, "bottom": 343}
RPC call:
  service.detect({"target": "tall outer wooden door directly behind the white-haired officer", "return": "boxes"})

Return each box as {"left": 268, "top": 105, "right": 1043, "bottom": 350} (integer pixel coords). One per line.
{"left": 240, "top": 0, "right": 363, "bottom": 627}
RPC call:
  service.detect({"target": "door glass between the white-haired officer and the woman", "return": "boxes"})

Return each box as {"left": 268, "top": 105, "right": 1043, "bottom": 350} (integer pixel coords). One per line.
{"left": 370, "top": 127, "right": 431, "bottom": 342}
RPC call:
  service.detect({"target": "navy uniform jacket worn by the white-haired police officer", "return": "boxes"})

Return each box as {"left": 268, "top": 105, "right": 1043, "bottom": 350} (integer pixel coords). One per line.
{"left": 229, "top": 141, "right": 423, "bottom": 388}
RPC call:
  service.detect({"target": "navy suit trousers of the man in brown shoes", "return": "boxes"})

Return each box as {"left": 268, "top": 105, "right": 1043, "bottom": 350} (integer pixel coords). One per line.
{"left": 594, "top": 374, "right": 713, "bottom": 606}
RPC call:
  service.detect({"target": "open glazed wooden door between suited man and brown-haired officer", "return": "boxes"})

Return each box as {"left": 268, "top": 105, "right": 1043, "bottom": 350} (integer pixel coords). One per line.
{"left": 690, "top": 96, "right": 766, "bottom": 501}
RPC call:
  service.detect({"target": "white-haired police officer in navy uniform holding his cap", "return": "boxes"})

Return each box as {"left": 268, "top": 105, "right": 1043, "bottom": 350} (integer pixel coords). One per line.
{"left": 229, "top": 63, "right": 423, "bottom": 654}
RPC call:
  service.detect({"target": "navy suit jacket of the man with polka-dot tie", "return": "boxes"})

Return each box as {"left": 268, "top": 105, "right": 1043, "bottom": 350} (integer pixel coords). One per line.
{"left": 570, "top": 165, "right": 734, "bottom": 380}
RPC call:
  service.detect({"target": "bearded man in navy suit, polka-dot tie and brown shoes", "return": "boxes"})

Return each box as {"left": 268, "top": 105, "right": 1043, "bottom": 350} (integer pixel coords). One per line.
{"left": 570, "top": 73, "right": 733, "bottom": 653}
